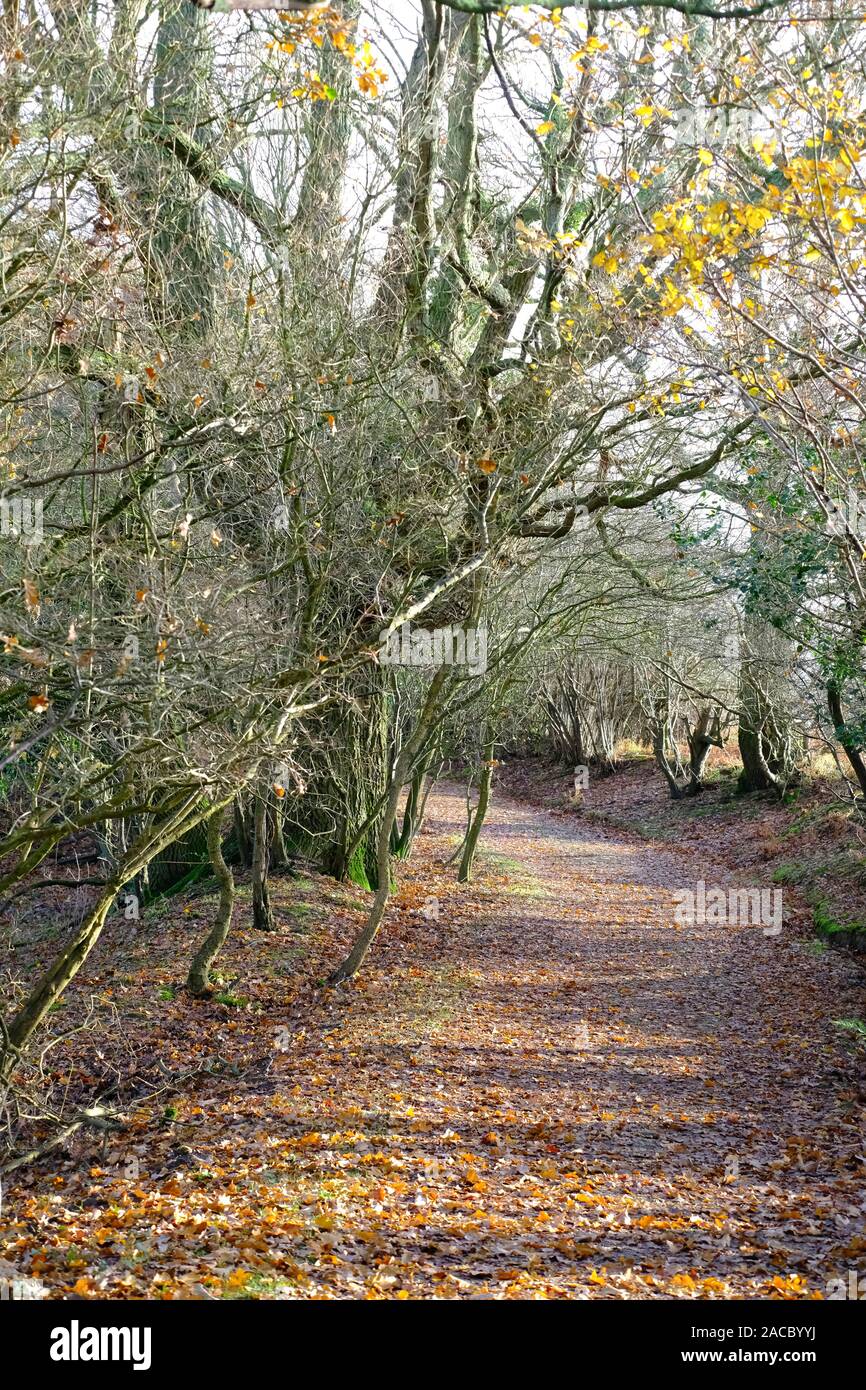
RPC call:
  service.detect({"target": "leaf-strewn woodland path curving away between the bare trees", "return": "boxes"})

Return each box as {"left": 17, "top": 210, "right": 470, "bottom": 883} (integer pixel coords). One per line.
{"left": 218, "top": 788, "right": 866, "bottom": 1298}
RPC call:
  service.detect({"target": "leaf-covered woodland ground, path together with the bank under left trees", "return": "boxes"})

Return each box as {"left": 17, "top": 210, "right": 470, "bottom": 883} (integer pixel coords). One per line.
{"left": 0, "top": 787, "right": 866, "bottom": 1298}
